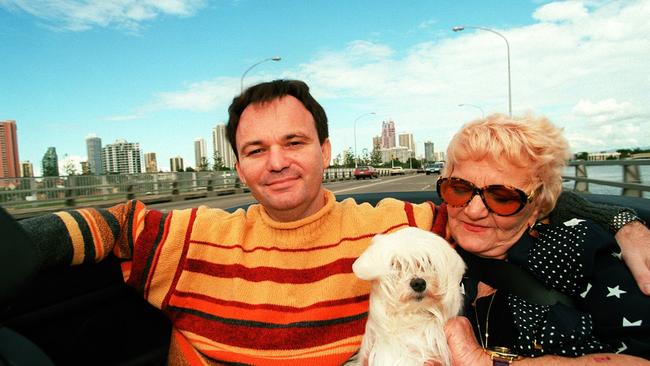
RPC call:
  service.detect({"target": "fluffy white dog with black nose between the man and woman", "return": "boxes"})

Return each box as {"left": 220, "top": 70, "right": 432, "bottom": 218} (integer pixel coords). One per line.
{"left": 352, "top": 227, "right": 465, "bottom": 366}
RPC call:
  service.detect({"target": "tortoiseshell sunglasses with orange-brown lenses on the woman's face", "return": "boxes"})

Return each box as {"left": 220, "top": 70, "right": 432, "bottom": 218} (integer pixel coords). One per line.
{"left": 436, "top": 177, "right": 541, "bottom": 216}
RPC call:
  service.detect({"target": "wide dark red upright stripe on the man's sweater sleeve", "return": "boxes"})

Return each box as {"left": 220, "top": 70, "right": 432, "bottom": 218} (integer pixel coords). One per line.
{"left": 127, "top": 211, "right": 162, "bottom": 292}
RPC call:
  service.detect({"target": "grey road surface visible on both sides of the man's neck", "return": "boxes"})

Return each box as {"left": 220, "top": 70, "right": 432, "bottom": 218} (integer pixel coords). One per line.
{"left": 147, "top": 174, "right": 437, "bottom": 211}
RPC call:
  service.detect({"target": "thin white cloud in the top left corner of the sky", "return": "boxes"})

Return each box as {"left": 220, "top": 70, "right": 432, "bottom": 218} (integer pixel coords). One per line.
{"left": 0, "top": 0, "right": 205, "bottom": 32}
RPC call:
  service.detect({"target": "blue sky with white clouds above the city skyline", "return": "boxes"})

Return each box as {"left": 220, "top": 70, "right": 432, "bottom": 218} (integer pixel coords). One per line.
{"left": 0, "top": 0, "right": 650, "bottom": 174}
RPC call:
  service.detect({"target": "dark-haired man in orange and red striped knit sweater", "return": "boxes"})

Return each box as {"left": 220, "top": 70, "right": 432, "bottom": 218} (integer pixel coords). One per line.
{"left": 3, "top": 80, "right": 650, "bottom": 365}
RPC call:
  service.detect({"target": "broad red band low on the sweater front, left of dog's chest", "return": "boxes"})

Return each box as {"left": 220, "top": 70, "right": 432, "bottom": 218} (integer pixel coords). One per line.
{"left": 170, "top": 309, "right": 367, "bottom": 350}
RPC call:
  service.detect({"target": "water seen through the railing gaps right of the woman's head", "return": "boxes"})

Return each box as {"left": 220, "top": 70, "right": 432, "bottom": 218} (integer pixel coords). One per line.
{"left": 562, "top": 165, "right": 650, "bottom": 198}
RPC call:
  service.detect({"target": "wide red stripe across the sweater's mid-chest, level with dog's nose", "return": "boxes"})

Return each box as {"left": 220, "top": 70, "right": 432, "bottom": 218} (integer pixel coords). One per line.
{"left": 185, "top": 258, "right": 356, "bottom": 284}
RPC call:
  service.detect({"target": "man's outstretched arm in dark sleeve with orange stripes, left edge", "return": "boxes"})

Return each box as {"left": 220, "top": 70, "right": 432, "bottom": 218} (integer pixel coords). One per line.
{"left": 0, "top": 201, "right": 145, "bottom": 302}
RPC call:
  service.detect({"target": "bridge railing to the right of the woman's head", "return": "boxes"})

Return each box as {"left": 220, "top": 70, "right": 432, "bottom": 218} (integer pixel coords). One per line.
{"left": 562, "top": 159, "right": 650, "bottom": 197}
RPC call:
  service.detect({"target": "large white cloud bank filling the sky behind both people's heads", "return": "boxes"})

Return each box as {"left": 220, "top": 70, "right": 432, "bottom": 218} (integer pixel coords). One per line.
{"left": 111, "top": 0, "right": 650, "bottom": 155}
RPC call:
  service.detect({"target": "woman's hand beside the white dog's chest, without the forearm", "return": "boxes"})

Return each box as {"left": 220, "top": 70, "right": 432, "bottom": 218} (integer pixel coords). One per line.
{"left": 445, "top": 316, "right": 492, "bottom": 366}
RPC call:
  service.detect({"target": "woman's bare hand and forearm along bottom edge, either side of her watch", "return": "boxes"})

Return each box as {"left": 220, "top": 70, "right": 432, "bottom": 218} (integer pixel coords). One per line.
{"left": 445, "top": 316, "right": 650, "bottom": 366}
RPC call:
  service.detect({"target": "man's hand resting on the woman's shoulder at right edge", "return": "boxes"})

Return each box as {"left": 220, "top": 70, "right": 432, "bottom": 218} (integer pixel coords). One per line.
{"left": 616, "top": 221, "right": 650, "bottom": 295}
